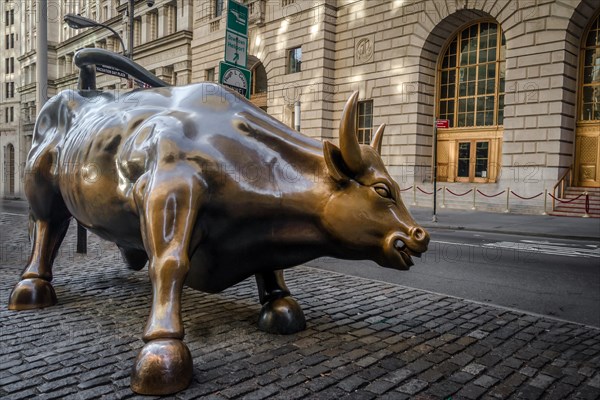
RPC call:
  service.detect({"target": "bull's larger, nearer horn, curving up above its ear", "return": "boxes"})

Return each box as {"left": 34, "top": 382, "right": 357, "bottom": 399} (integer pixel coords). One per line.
{"left": 340, "top": 92, "right": 364, "bottom": 174}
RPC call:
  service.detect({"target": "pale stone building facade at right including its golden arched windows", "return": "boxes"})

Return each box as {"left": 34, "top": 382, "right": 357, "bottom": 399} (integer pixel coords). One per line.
{"left": 192, "top": 0, "right": 600, "bottom": 212}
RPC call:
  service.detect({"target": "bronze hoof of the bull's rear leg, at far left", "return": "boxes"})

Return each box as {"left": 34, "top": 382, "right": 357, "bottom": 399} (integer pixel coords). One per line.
{"left": 8, "top": 278, "right": 56, "bottom": 310}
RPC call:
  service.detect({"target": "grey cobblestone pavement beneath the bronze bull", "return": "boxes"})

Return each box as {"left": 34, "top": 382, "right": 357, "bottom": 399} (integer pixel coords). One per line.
{"left": 0, "top": 215, "right": 600, "bottom": 400}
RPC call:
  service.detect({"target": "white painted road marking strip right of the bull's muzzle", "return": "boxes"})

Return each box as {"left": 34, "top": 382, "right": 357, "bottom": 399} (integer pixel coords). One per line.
{"left": 432, "top": 240, "right": 600, "bottom": 258}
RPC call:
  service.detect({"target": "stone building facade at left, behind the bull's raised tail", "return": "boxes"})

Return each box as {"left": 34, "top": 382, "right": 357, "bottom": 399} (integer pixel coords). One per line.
{"left": 0, "top": 0, "right": 193, "bottom": 197}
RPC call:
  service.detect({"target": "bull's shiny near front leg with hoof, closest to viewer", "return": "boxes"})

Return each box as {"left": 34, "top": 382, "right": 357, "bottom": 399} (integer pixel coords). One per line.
{"left": 131, "top": 165, "right": 203, "bottom": 395}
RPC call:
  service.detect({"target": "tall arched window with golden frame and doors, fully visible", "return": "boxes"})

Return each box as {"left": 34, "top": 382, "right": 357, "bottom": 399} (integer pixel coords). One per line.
{"left": 437, "top": 22, "right": 506, "bottom": 182}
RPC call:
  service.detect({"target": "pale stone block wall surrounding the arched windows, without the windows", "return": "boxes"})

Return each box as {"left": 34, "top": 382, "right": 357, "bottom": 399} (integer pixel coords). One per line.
{"left": 192, "top": 0, "right": 600, "bottom": 214}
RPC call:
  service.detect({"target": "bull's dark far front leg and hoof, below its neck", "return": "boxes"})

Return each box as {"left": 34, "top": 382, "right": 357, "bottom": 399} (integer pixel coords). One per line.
{"left": 256, "top": 270, "right": 306, "bottom": 335}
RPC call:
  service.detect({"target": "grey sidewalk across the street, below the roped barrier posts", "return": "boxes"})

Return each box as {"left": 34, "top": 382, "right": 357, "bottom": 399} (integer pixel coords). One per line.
{"left": 409, "top": 207, "right": 600, "bottom": 241}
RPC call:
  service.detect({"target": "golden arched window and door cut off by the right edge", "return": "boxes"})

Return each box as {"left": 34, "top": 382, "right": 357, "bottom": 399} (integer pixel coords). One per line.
{"left": 574, "top": 14, "right": 600, "bottom": 187}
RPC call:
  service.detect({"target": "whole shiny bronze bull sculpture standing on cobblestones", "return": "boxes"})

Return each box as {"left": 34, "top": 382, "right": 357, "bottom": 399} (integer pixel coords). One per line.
{"left": 9, "top": 83, "right": 429, "bottom": 395}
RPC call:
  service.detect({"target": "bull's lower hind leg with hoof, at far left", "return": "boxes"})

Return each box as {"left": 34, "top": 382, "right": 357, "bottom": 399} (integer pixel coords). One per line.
{"left": 8, "top": 182, "right": 71, "bottom": 310}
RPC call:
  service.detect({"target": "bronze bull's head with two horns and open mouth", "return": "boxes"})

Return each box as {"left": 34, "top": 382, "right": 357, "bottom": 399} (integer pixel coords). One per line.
{"left": 323, "top": 92, "right": 429, "bottom": 270}
